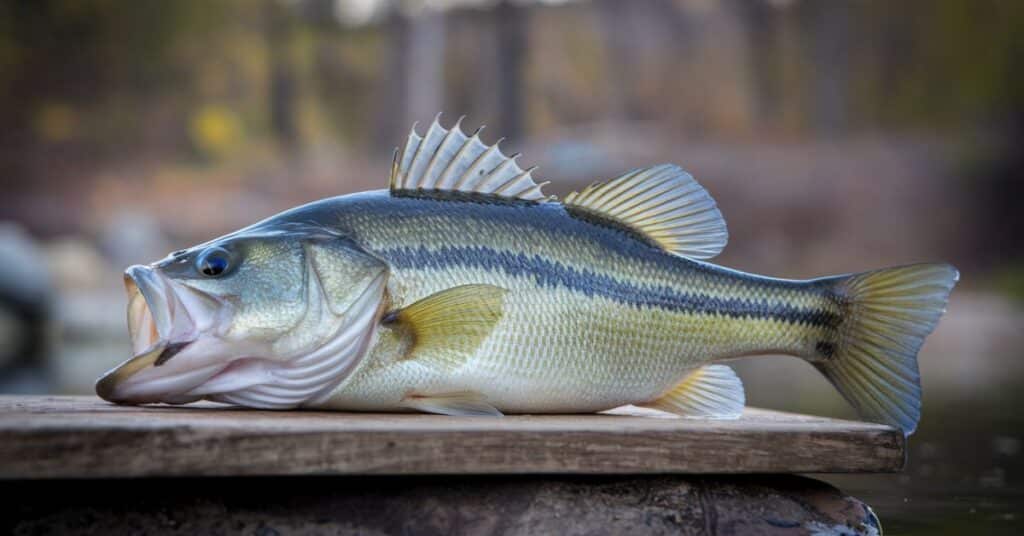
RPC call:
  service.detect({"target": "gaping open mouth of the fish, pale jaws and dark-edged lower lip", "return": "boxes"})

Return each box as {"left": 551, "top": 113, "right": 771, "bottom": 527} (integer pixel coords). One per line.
{"left": 96, "top": 265, "right": 199, "bottom": 404}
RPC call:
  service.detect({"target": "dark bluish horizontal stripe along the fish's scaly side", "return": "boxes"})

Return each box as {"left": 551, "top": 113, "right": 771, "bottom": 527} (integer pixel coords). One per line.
{"left": 378, "top": 246, "right": 840, "bottom": 327}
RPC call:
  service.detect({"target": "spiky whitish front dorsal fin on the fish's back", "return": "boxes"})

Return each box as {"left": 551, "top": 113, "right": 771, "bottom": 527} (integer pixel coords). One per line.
{"left": 390, "top": 114, "right": 548, "bottom": 202}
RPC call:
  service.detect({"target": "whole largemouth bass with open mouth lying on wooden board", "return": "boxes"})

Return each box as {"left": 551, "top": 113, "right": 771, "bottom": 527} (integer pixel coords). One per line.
{"left": 96, "top": 116, "right": 959, "bottom": 435}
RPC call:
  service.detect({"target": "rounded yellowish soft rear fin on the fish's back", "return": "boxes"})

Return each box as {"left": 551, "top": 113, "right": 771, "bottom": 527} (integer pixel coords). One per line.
{"left": 563, "top": 164, "right": 729, "bottom": 258}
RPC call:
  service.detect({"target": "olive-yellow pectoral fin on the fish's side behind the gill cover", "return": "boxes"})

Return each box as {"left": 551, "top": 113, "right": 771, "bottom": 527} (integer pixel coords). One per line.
{"left": 383, "top": 285, "right": 508, "bottom": 370}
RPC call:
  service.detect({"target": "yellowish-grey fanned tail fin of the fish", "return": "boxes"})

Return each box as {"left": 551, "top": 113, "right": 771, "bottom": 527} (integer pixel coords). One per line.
{"left": 814, "top": 264, "right": 959, "bottom": 436}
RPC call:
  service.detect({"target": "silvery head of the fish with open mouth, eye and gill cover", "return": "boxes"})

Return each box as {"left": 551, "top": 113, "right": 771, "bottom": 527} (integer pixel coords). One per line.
{"left": 96, "top": 224, "right": 387, "bottom": 408}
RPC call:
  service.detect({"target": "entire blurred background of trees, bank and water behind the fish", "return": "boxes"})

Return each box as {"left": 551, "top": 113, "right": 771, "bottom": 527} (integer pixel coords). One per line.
{"left": 0, "top": 0, "right": 1024, "bottom": 534}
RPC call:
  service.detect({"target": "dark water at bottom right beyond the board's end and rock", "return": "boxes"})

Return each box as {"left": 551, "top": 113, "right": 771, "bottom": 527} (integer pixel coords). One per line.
{"left": 818, "top": 393, "right": 1024, "bottom": 536}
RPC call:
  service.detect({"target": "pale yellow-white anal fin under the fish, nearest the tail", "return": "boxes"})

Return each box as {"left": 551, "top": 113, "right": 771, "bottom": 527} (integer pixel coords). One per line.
{"left": 639, "top": 365, "right": 745, "bottom": 419}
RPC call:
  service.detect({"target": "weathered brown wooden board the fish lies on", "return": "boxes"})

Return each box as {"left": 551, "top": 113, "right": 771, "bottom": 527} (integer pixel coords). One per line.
{"left": 0, "top": 396, "right": 905, "bottom": 479}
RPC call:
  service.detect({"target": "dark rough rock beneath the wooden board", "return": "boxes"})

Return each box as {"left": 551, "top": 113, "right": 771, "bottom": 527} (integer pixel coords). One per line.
{"left": 6, "top": 476, "right": 881, "bottom": 536}
